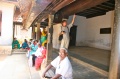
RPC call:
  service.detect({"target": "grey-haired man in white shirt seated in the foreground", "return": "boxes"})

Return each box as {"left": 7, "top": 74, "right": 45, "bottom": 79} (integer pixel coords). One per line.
{"left": 42, "top": 48, "right": 73, "bottom": 79}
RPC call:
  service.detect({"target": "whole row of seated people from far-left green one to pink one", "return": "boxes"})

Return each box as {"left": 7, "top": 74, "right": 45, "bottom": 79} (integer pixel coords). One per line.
{"left": 12, "top": 38, "right": 47, "bottom": 70}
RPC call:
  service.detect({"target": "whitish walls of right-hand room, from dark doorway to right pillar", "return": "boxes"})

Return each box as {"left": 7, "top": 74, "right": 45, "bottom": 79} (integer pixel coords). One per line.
{"left": 68, "top": 11, "right": 114, "bottom": 50}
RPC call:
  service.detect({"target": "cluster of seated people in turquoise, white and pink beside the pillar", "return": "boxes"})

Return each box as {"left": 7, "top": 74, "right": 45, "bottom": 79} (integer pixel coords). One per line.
{"left": 27, "top": 40, "right": 47, "bottom": 70}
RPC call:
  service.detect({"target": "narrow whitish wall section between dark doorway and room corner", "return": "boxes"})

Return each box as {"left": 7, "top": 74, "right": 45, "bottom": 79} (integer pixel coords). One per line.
{"left": 68, "top": 16, "right": 87, "bottom": 46}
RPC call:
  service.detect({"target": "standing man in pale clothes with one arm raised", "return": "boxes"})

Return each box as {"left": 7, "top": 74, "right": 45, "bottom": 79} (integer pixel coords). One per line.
{"left": 59, "top": 15, "right": 76, "bottom": 49}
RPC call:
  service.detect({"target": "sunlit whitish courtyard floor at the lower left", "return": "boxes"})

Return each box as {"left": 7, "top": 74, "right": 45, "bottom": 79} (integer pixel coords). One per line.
{"left": 0, "top": 54, "right": 40, "bottom": 79}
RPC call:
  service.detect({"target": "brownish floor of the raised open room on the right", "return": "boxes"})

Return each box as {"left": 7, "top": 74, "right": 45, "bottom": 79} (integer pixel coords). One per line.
{"left": 69, "top": 47, "right": 111, "bottom": 71}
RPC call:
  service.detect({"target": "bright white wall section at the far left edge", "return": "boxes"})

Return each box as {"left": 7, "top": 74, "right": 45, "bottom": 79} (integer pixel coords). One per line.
{"left": 0, "top": 2, "right": 14, "bottom": 46}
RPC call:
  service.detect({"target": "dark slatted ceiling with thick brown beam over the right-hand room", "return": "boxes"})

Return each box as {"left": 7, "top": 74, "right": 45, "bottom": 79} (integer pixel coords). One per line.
{"left": 58, "top": 0, "right": 115, "bottom": 18}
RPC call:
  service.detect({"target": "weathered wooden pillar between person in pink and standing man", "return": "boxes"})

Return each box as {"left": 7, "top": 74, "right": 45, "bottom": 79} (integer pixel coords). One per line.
{"left": 47, "top": 14, "right": 54, "bottom": 64}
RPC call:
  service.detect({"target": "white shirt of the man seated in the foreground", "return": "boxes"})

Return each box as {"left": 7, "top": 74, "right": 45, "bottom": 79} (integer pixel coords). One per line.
{"left": 51, "top": 56, "right": 73, "bottom": 79}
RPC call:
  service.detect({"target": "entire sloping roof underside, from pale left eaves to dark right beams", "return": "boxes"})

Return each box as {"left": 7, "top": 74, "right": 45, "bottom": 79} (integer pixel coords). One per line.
{"left": 0, "top": 0, "right": 115, "bottom": 28}
